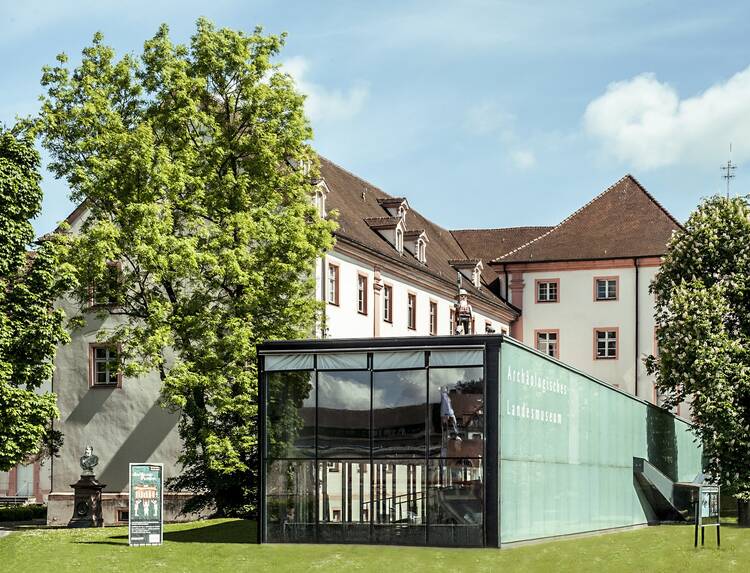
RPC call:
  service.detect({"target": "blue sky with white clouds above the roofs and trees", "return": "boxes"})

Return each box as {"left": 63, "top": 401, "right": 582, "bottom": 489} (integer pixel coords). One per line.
{"left": 0, "top": 0, "right": 750, "bottom": 234}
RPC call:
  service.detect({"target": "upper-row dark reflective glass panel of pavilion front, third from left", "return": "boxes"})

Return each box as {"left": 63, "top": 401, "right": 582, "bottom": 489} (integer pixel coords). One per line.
{"left": 372, "top": 370, "right": 427, "bottom": 458}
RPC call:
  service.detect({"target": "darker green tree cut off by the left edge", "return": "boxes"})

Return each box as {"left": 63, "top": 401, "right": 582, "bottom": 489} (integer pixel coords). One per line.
{"left": 0, "top": 126, "right": 72, "bottom": 470}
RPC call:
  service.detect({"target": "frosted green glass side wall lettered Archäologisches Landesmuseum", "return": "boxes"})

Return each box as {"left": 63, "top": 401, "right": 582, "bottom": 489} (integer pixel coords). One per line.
{"left": 498, "top": 339, "right": 701, "bottom": 543}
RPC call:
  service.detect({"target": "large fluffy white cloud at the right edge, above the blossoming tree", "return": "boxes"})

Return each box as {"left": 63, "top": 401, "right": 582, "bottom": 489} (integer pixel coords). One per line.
{"left": 583, "top": 67, "right": 750, "bottom": 169}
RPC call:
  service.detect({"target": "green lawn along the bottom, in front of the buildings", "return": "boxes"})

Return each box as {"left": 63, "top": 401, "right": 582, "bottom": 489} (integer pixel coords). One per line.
{"left": 0, "top": 519, "right": 750, "bottom": 573}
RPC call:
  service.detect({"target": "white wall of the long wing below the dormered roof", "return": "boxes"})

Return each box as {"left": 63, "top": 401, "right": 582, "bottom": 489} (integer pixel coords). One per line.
{"left": 325, "top": 252, "right": 509, "bottom": 338}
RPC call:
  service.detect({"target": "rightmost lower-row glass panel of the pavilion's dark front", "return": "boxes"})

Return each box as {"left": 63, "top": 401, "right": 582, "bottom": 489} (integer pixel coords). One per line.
{"left": 427, "top": 458, "right": 484, "bottom": 546}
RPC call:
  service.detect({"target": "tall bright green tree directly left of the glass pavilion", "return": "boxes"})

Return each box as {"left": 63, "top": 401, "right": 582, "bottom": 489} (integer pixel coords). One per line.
{"left": 36, "top": 19, "right": 333, "bottom": 515}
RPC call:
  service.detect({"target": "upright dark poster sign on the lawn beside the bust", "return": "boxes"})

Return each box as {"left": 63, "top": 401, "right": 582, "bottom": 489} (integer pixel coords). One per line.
{"left": 128, "top": 464, "right": 164, "bottom": 545}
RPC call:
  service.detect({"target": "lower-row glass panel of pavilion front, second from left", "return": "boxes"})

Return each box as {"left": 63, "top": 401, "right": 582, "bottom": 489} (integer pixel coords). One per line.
{"left": 318, "top": 460, "right": 372, "bottom": 543}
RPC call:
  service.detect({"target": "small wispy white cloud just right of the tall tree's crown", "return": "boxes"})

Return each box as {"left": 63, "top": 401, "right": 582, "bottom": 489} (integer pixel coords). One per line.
{"left": 281, "top": 56, "right": 368, "bottom": 122}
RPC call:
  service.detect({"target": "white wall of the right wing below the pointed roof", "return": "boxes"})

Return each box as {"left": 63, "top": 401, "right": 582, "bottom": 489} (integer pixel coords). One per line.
{"left": 522, "top": 267, "right": 657, "bottom": 400}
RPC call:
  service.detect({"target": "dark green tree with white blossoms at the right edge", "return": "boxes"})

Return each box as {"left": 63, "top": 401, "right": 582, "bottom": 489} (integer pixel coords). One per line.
{"left": 647, "top": 196, "right": 750, "bottom": 525}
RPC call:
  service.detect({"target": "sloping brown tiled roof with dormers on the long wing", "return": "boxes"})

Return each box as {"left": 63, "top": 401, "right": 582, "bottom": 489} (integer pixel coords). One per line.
{"left": 320, "top": 157, "right": 517, "bottom": 314}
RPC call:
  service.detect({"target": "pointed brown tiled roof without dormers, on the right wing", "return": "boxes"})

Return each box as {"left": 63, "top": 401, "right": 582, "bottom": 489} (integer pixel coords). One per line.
{"left": 493, "top": 175, "right": 681, "bottom": 263}
